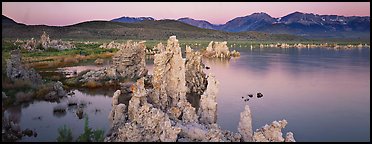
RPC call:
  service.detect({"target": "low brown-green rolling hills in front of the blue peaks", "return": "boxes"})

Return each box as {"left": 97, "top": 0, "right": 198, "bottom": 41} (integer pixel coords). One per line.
{"left": 2, "top": 15, "right": 305, "bottom": 41}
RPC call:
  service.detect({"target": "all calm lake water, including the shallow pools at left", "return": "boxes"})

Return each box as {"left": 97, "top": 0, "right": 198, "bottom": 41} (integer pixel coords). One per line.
{"left": 4, "top": 48, "right": 370, "bottom": 141}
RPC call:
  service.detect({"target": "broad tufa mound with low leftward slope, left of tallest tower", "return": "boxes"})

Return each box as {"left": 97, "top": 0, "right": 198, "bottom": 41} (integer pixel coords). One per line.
{"left": 79, "top": 41, "right": 147, "bottom": 83}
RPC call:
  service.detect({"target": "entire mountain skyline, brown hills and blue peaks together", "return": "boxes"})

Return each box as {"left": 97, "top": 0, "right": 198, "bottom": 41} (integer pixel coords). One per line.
{"left": 2, "top": 12, "right": 370, "bottom": 41}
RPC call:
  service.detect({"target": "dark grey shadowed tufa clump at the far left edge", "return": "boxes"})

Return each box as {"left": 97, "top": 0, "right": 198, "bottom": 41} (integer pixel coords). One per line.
{"left": 6, "top": 49, "right": 42, "bottom": 86}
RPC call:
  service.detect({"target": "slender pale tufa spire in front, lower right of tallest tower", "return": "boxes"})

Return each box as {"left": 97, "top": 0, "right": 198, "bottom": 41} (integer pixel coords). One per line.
{"left": 198, "top": 74, "right": 219, "bottom": 124}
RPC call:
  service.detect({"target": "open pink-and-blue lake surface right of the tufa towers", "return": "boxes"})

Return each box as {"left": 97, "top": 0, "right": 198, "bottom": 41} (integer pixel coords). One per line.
{"left": 209, "top": 48, "right": 370, "bottom": 141}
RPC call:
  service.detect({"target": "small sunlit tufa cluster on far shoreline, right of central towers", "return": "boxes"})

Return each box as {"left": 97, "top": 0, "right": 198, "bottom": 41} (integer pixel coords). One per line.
{"left": 204, "top": 41, "right": 240, "bottom": 58}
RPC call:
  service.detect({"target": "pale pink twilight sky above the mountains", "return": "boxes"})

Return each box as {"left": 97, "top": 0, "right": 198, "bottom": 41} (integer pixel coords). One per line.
{"left": 1, "top": 2, "right": 370, "bottom": 26}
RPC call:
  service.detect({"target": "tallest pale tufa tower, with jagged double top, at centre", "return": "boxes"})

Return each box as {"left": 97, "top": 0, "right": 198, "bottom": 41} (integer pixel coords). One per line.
{"left": 151, "top": 36, "right": 187, "bottom": 110}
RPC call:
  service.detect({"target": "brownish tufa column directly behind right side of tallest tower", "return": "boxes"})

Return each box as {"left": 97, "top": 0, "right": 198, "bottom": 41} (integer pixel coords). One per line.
{"left": 185, "top": 46, "right": 207, "bottom": 94}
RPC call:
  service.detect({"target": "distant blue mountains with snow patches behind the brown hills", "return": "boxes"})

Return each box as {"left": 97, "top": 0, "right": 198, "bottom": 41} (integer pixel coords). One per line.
{"left": 112, "top": 12, "right": 370, "bottom": 38}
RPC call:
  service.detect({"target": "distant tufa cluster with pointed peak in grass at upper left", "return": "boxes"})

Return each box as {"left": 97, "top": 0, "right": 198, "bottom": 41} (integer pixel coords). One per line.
{"left": 21, "top": 32, "right": 75, "bottom": 51}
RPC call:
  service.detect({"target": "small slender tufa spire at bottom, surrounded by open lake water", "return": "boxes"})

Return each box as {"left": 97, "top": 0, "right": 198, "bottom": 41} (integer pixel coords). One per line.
{"left": 238, "top": 105, "right": 253, "bottom": 142}
